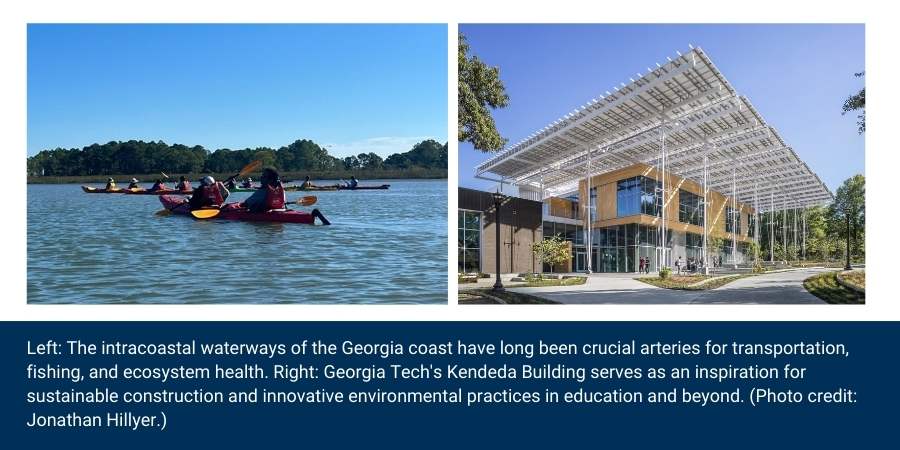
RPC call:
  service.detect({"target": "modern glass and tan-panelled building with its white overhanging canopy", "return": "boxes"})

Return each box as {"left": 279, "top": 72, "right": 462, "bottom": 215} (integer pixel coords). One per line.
{"left": 475, "top": 47, "right": 832, "bottom": 272}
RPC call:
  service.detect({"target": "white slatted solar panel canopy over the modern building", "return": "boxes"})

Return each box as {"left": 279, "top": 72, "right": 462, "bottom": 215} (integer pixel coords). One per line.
{"left": 475, "top": 47, "right": 833, "bottom": 212}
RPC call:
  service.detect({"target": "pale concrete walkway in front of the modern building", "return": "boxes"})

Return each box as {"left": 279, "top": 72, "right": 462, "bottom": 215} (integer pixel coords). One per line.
{"left": 510, "top": 269, "right": 826, "bottom": 305}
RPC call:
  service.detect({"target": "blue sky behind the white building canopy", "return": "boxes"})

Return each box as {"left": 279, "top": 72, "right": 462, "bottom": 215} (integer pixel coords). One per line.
{"left": 459, "top": 24, "right": 865, "bottom": 192}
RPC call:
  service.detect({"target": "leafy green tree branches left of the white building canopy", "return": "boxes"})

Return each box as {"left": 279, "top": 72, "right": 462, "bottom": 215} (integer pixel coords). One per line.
{"left": 456, "top": 34, "right": 509, "bottom": 152}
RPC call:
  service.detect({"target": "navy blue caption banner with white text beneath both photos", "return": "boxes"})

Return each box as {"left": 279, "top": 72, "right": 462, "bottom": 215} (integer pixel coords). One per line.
{"left": 0, "top": 322, "right": 900, "bottom": 449}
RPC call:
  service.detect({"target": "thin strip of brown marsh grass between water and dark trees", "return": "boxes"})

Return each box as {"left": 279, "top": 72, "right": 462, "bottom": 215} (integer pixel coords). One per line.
{"left": 27, "top": 167, "right": 447, "bottom": 185}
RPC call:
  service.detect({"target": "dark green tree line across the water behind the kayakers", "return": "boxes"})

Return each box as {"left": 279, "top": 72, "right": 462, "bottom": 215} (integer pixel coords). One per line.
{"left": 28, "top": 139, "right": 447, "bottom": 177}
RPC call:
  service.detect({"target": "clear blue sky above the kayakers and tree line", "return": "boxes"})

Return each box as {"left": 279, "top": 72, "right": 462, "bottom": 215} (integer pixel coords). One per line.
{"left": 28, "top": 24, "right": 447, "bottom": 156}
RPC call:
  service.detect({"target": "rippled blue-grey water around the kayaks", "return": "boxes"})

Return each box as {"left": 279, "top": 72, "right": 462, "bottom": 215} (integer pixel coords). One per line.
{"left": 28, "top": 180, "right": 448, "bottom": 303}
